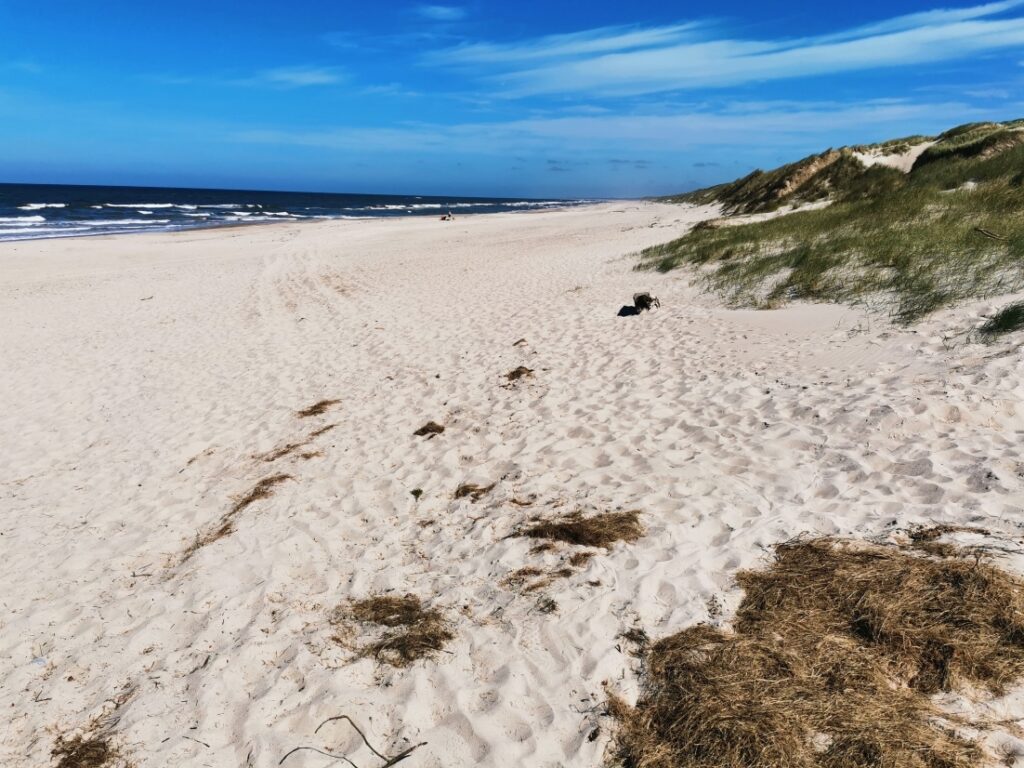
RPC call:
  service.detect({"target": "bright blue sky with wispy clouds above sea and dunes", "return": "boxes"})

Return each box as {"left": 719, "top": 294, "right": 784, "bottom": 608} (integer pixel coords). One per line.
{"left": 0, "top": 0, "right": 1024, "bottom": 197}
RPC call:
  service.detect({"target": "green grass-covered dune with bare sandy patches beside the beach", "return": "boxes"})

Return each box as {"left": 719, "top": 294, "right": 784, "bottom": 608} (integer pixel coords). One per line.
{"left": 641, "top": 120, "right": 1024, "bottom": 323}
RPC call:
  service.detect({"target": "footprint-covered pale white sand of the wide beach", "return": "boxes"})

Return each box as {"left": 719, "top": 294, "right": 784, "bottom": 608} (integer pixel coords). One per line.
{"left": 0, "top": 204, "right": 1024, "bottom": 768}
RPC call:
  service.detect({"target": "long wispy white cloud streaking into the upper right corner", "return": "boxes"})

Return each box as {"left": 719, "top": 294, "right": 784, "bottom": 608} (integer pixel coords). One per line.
{"left": 425, "top": 0, "right": 1024, "bottom": 97}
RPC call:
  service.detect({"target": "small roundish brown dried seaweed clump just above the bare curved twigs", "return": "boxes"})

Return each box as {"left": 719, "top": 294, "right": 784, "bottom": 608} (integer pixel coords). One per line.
{"left": 331, "top": 595, "right": 455, "bottom": 668}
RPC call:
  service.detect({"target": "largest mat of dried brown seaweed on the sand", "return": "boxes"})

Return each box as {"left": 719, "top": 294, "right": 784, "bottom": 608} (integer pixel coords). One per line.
{"left": 612, "top": 539, "right": 1024, "bottom": 768}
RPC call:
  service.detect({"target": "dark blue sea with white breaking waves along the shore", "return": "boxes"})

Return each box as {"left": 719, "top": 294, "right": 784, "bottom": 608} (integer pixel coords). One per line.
{"left": 0, "top": 184, "right": 594, "bottom": 241}
